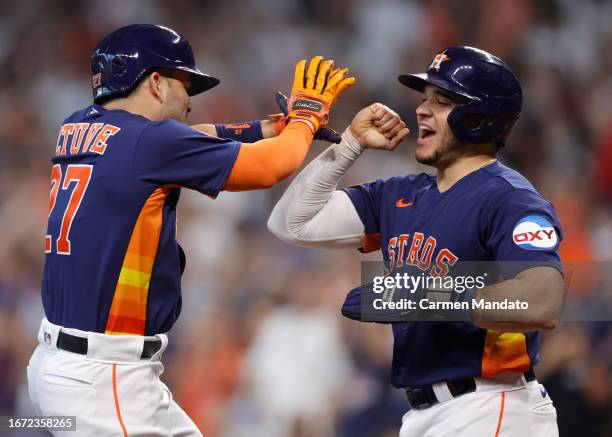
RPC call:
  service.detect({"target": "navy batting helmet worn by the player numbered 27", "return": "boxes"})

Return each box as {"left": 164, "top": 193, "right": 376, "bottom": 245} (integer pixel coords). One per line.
{"left": 91, "top": 24, "right": 219, "bottom": 103}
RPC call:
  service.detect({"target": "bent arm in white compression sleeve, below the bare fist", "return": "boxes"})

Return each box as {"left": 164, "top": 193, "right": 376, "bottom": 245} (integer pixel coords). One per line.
{"left": 268, "top": 127, "right": 364, "bottom": 248}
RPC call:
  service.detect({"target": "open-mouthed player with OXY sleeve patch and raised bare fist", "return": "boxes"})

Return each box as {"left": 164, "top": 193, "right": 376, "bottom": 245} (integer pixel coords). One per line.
{"left": 268, "top": 46, "right": 563, "bottom": 437}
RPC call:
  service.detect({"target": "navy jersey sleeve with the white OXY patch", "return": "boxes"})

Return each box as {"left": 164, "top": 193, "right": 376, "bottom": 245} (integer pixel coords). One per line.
{"left": 486, "top": 189, "right": 563, "bottom": 278}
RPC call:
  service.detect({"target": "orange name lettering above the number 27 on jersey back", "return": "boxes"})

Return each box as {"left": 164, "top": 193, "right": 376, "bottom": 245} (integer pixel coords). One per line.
{"left": 55, "top": 123, "right": 121, "bottom": 156}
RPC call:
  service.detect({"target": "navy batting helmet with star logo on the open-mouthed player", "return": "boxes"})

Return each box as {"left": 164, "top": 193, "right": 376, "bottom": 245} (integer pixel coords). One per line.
{"left": 399, "top": 46, "right": 523, "bottom": 146}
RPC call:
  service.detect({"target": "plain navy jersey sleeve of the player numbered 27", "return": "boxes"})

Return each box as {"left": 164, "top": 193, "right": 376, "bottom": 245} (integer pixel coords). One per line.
{"left": 134, "top": 120, "right": 240, "bottom": 197}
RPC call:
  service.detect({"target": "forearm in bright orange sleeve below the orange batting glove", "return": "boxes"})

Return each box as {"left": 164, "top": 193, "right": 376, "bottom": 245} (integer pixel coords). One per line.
{"left": 224, "top": 122, "right": 313, "bottom": 191}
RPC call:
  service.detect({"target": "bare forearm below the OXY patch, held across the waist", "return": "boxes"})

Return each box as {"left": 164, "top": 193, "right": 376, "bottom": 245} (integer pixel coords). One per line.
{"left": 473, "top": 267, "right": 563, "bottom": 332}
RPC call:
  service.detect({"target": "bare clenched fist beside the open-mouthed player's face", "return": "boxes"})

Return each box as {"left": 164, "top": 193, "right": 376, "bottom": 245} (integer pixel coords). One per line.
{"left": 350, "top": 103, "right": 410, "bottom": 150}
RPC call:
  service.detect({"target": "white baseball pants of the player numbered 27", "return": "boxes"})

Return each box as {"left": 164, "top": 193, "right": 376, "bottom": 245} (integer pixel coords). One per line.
{"left": 27, "top": 319, "right": 202, "bottom": 437}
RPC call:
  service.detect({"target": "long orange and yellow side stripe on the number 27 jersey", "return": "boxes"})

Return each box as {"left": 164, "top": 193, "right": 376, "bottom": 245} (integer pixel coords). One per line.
{"left": 105, "top": 187, "right": 170, "bottom": 335}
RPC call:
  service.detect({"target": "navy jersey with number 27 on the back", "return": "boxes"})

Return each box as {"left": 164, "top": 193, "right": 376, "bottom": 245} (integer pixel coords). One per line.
{"left": 42, "top": 104, "right": 240, "bottom": 335}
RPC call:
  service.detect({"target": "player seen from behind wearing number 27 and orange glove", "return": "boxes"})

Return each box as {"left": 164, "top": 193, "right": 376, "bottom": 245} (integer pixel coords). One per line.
{"left": 27, "top": 25, "right": 364, "bottom": 437}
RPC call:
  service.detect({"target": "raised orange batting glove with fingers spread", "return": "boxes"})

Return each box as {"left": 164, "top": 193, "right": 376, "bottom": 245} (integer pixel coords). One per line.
{"left": 288, "top": 56, "right": 355, "bottom": 133}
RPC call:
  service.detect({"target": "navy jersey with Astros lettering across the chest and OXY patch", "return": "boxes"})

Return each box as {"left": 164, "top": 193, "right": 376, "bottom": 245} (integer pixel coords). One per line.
{"left": 345, "top": 161, "right": 562, "bottom": 387}
